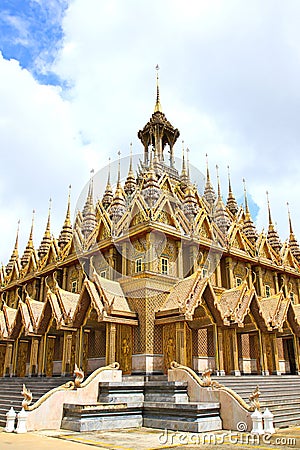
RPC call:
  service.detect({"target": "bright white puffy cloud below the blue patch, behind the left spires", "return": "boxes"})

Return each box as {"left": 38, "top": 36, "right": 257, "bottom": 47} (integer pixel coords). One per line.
{"left": 0, "top": 55, "right": 89, "bottom": 261}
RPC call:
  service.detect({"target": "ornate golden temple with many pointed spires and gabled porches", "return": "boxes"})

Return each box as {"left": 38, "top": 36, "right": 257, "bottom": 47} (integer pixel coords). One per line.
{"left": 0, "top": 74, "right": 300, "bottom": 377}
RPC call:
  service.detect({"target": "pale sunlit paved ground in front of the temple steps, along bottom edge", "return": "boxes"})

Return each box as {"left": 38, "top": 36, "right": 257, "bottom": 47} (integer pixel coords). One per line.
{"left": 0, "top": 427, "right": 300, "bottom": 450}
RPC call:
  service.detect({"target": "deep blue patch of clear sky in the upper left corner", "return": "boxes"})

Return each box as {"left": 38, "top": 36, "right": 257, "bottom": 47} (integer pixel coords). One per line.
{"left": 0, "top": 0, "right": 68, "bottom": 84}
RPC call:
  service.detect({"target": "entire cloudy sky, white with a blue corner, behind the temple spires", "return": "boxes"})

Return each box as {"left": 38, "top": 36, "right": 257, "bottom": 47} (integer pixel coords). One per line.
{"left": 0, "top": 0, "right": 300, "bottom": 262}
